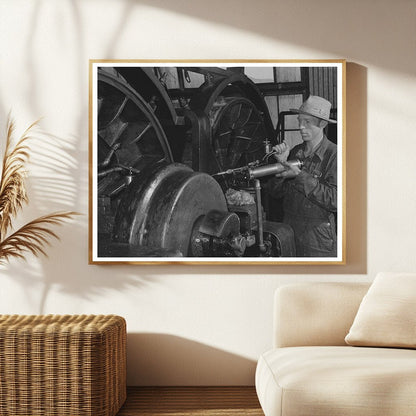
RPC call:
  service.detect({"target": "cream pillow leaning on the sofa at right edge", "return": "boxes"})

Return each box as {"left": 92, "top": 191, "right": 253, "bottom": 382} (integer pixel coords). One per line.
{"left": 345, "top": 273, "right": 416, "bottom": 348}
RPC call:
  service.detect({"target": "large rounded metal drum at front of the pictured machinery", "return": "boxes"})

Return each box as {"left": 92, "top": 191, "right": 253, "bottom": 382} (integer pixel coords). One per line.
{"left": 114, "top": 163, "right": 227, "bottom": 256}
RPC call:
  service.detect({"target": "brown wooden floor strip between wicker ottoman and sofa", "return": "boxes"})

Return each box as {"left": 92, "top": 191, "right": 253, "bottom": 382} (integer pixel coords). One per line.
{"left": 117, "top": 387, "right": 264, "bottom": 416}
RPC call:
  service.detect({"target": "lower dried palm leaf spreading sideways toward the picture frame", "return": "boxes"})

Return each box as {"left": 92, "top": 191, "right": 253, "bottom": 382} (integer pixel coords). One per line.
{"left": 0, "top": 211, "right": 78, "bottom": 264}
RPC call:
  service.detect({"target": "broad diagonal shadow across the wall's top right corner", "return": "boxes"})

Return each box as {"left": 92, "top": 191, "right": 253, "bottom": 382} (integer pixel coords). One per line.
{"left": 132, "top": 0, "right": 415, "bottom": 75}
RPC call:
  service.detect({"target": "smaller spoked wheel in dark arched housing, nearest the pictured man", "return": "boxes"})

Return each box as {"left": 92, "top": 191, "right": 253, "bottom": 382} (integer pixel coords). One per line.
{"left": 210, "top": 96, "right": 267, "bottom": 170}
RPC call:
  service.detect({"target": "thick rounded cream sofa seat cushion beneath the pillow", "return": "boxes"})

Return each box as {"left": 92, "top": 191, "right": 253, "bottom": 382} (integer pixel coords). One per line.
{"left": 256, "top": 346, "right": 416, "bottom": 416}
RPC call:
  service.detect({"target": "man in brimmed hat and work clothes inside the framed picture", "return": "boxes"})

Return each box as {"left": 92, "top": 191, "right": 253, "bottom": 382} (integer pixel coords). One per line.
{"left": 267, "top": 95, "right": 337, "bottom": 257}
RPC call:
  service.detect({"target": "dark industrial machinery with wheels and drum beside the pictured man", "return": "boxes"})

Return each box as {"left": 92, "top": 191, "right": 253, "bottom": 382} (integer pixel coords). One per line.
{"left": 97, "top": 66, "right": 298, "bottom": 257}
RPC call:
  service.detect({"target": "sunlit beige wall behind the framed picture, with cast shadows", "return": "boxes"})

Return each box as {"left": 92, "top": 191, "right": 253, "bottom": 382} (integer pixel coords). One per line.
{"left": 0, "top": 0, "right": 416, "bottom": 385}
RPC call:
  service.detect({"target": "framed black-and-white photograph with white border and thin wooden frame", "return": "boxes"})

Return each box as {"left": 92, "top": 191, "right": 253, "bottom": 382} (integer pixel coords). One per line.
{"left": 89, "top": 60, "right": 346, "bottom": 265}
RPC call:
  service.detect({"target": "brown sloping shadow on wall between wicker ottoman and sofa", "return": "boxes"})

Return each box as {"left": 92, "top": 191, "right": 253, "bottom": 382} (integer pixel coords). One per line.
{"left": 127, "top": 333, "right": 256, "bottom": 386}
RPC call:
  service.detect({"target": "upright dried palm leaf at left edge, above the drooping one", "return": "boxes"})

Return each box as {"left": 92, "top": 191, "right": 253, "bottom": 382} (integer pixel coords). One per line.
{"left": 0, "top": 117, "right": 37, "bottom": 237}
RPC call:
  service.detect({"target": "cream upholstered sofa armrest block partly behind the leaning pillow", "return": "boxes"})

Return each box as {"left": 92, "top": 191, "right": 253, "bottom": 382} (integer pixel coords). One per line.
{"left": 273, "top": 282, "right": 370, "bottom": 348}
